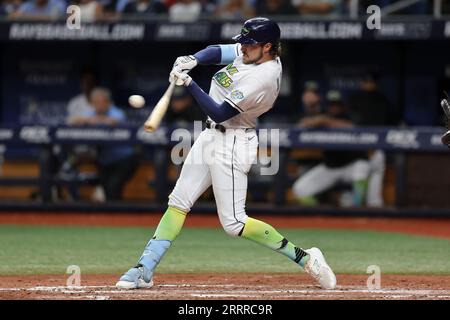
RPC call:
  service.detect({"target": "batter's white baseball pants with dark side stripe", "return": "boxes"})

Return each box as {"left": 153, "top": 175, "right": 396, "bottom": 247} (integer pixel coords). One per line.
{"left": 169, "top": 129, "right": 258, "bottom": 236}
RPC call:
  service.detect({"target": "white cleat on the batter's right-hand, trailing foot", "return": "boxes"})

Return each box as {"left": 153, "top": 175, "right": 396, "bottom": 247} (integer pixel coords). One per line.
{"left": 305, "top": 247, "right": 336, "bottom": 290}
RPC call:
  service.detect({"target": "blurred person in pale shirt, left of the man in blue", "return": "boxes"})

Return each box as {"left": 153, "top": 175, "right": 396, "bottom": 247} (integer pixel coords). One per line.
{"left": 66, "top": 71, "right": 97, "bottom": 124}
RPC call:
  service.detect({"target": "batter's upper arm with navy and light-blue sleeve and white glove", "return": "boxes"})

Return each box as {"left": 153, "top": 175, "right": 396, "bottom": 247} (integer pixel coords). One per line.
{"left": 173, "top": 43, "right": 240, "bottom": 72}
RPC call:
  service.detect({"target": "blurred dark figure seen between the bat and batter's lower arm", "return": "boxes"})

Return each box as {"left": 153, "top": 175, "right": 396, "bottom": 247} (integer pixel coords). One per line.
{"left": 164, "top": 87, "right": 206, "bottom": 127}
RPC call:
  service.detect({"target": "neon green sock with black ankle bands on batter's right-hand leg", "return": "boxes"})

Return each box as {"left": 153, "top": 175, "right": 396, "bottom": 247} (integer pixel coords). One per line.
{"left": 241, "top": 218, "right": 309, "bottom": 267}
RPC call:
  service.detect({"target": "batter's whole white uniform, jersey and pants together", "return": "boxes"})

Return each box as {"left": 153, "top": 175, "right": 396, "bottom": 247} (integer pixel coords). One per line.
{"left": 168, "top": 44, "right": 282, "bottom": 236}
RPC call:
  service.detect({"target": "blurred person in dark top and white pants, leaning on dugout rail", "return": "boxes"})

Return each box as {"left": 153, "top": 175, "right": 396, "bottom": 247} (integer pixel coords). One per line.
{"left": 293, "top": 91, "right": 370, "bottom": 206}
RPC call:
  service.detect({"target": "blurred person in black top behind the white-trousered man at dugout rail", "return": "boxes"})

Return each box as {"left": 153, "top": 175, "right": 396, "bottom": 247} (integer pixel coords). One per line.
{"left": 348, "top": 72, "right": 397, "bottom": 207}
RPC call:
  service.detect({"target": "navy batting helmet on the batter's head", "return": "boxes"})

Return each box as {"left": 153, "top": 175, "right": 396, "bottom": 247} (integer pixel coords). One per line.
{"left": 233, "top": 17, "right": 281, "bottom": 45}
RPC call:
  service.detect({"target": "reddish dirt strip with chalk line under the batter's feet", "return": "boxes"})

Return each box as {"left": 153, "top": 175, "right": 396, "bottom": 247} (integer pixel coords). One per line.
{"left": 0, "top": 273, "right": 450, "bottom": 300}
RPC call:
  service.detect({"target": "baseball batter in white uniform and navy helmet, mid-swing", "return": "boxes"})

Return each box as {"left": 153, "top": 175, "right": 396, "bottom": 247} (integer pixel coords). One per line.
{"left": 116, "top": 17, "right": 336, "bottom": 289}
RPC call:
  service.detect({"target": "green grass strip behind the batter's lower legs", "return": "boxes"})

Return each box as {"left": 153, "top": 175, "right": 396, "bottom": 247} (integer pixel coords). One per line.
{"left": 0, "top": 225, "right": 450, "bottom": 275}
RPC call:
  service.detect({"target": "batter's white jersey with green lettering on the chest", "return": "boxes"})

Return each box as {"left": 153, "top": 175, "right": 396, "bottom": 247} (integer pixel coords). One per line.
{"left": 209, "top": 44, "right": 282, "bottom": 128}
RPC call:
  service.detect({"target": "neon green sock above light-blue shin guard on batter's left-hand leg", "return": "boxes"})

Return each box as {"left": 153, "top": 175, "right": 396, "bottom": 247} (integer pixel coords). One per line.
{"left": 153, "top": 207, "right": 186, "bottom": 241}
